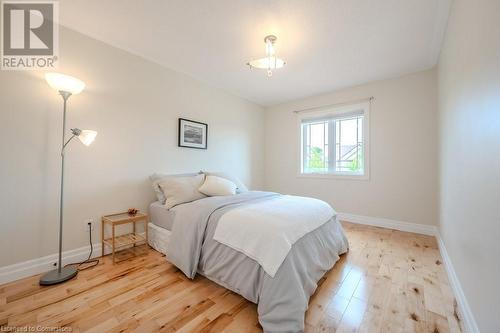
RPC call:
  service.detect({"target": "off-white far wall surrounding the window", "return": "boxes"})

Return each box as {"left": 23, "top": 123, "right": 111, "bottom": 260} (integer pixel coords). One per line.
{"left": 265, "top": 70, "right": 438, "bottom": 225}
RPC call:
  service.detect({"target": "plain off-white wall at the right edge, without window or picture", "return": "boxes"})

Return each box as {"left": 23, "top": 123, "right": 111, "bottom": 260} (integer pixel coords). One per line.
{"left": 438, "top": 0, "right": 500, "bottom": 333}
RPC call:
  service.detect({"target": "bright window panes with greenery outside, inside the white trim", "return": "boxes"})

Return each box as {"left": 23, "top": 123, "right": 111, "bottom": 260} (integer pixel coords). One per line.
{"left": 299, "top": 104, "right": 369, "bottom": 178}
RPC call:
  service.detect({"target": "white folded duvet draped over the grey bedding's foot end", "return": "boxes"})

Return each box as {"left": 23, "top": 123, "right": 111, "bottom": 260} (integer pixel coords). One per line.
{"left": 214, "top": 195, "right": 336, "bottom": 277}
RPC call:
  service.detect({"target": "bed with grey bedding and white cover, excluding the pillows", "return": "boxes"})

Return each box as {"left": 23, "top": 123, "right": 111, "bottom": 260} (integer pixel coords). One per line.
{"left": 149, "top": 191, "right": 348, "bottom": 332}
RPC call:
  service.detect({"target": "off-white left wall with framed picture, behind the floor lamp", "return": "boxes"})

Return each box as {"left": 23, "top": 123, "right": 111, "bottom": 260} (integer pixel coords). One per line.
{"left": 0, "top": 29, "right": 264, "bottom": 267}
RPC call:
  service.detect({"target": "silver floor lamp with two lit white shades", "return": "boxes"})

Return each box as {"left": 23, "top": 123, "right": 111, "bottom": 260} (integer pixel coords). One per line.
{"left": 40, "top": 73, "right": 97, "bottom": 286}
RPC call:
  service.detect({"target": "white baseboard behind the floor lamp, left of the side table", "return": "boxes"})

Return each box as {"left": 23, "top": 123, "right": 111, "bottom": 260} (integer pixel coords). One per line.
{"left": 0, "top": 243, "right": 101, "bottom": 284}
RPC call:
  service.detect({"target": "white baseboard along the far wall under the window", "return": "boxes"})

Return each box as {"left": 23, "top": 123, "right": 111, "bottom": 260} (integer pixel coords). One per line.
{"left": 338, "top": 213, "right": 437, "bottom": 236}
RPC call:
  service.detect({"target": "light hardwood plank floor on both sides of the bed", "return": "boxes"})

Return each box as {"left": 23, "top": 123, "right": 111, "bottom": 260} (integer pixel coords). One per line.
{"left": 0, "top": 223, "right": 461, "bottom": 333}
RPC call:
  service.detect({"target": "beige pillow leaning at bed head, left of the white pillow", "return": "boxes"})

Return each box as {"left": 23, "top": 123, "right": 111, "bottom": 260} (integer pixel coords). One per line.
{"left": 158, "top": 174, "right": 205, "bottom": 209}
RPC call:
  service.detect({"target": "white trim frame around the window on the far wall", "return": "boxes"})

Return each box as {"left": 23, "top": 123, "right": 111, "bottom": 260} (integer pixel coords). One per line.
{"left": 297, "top": 102, "right": 370, "bottom": 180}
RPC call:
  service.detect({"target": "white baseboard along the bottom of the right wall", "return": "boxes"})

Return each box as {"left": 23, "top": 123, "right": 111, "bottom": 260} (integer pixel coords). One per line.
{"left": 436, "top": 232, "right": 479, "bottom": 333}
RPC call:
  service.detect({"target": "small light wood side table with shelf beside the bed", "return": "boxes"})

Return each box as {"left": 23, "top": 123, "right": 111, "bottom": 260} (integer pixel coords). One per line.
{"left": 101, "top": 212, "right": 148, "bottom": 263}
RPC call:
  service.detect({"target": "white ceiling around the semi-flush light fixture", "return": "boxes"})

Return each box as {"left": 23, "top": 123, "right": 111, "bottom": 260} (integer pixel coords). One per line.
{"left": 60, "top": 0, "right": 451, "bottom": 106}
